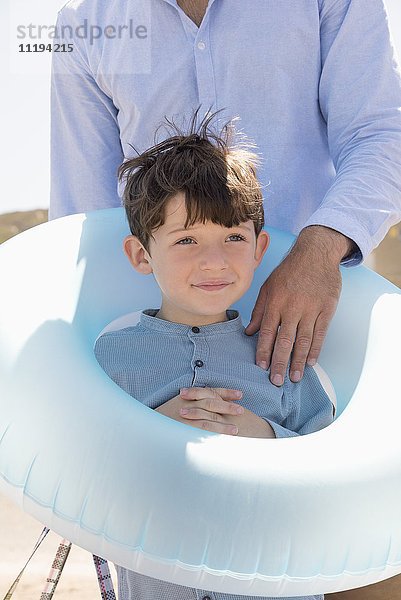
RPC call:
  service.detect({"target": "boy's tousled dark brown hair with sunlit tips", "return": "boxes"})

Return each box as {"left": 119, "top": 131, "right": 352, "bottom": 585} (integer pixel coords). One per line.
{"left": 118, "top": 108, "right": 264, "bottom": 251}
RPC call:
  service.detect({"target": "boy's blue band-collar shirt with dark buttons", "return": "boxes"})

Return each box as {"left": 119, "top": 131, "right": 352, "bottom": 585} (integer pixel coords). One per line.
{"left": 95, "top": 309, "right": 333, "bottom": 600}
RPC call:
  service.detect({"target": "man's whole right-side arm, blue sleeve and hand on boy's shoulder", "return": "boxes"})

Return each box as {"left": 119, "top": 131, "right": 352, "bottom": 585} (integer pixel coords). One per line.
{"left": 247, "top": 0, "right": 401, "bottom": 385}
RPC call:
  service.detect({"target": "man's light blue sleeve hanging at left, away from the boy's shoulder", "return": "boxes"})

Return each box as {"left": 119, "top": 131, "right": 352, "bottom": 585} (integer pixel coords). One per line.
{"left": 50, "top": 13, "right": 123, "bottom": 218}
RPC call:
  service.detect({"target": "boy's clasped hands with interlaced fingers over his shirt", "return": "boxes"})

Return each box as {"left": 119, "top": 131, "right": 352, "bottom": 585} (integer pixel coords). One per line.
{"left": 155, "top": 387, "right": 245, "bottom": 435}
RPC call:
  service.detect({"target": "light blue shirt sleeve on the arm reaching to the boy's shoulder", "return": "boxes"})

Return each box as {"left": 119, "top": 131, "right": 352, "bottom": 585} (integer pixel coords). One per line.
{"left": 304, "top": 0, "right": 401, "bottom": 255}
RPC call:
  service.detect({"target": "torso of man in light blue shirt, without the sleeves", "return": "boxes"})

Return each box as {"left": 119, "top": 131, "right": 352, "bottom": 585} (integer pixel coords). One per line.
{"left": 55, "top": 0, "right": 335, "bottom": 233}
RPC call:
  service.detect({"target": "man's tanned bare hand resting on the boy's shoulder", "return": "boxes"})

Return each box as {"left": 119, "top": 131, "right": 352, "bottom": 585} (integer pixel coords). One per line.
{"left": 245, "top": 225, "right": 356, "bottom": 386}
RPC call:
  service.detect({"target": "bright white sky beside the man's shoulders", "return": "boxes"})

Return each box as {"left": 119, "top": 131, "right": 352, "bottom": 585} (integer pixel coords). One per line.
{"left": 0, "top": 0, "right": 401, "bottom": 213}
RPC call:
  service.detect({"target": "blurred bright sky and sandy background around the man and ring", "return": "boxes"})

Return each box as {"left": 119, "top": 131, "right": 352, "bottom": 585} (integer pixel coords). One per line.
{"left": 0, "top": 0, "right": 401, "bottom": 600}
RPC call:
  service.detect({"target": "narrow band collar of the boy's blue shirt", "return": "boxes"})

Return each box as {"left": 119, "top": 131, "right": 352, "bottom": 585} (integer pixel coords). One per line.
{"left": 140, "top": 308, "right": 243, "bottom": 336}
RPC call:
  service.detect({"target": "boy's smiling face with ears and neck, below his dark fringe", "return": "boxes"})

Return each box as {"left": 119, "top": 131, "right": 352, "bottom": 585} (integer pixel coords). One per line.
{"left": 124, "top": 193, "right": 269, "bottom": 325}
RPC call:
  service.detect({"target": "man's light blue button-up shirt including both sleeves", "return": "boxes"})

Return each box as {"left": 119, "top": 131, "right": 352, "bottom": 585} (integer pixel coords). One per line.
{"left": 50, "top": 0, "right": 401, "bottom": 264}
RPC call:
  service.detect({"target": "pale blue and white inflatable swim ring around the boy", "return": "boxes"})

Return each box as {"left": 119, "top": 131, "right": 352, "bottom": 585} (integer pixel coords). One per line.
{"left": 0, "top": 209, "right": 401, "bottom": 597}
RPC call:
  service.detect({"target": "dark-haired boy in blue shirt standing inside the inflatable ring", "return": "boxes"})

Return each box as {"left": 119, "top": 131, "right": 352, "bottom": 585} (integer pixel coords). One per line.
{"left": 95, "top": 115, "right": 332, "bottom": 600}
